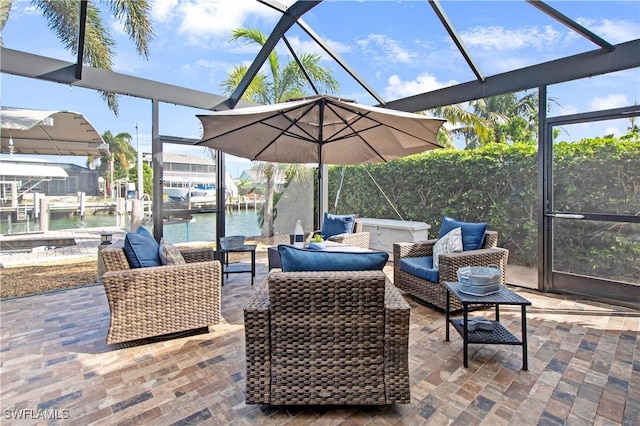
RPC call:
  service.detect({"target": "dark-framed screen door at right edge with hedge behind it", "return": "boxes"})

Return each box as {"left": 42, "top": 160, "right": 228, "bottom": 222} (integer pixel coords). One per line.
{"left": 546, "top": 111, "right": 640, "bottom": 306}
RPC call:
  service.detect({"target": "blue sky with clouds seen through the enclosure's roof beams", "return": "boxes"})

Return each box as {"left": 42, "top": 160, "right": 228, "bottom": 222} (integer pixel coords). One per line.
{"left": 0, "top": 0, "right": 640, "bottom": 176}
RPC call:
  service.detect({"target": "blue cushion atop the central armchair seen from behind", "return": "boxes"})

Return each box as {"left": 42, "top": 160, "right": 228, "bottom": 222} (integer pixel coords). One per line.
{"left": 278, "top": 244, "right": 389, "bottom": 272}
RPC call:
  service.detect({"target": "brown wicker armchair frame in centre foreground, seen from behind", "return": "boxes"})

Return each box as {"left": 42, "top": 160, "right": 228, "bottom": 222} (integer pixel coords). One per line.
{"left": 244, "top": 271, "right": 410, "bottom": 405}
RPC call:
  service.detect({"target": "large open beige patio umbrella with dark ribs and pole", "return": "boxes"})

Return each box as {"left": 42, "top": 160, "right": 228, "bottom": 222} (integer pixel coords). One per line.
{"left": 197, "top": 95, "right": 445, "bottom": 221}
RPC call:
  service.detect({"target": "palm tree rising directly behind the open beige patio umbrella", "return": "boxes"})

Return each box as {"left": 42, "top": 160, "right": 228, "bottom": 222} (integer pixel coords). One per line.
{"left": 221, "top": 28, "right": 339, "bottom": 237}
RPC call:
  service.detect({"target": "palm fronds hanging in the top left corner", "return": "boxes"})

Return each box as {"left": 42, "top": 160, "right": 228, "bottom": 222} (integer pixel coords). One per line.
{"left": 0, "top": 0, "right": 153, "bottom": 116}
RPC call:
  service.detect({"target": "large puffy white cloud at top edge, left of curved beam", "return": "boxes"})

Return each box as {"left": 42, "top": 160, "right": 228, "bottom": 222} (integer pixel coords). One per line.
{"left": 152, "top": 0, "right": 281, "bottom": 45}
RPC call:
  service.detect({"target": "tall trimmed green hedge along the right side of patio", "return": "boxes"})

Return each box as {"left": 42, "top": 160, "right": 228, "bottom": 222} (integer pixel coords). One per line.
{"left": 329, "top": 138, "right": 640, "bottom": 280}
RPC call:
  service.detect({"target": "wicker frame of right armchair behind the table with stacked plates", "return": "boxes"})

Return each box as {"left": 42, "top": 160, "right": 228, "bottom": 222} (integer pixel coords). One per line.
{"left": 393, "top": 231, "right": 509, "bottom": 311}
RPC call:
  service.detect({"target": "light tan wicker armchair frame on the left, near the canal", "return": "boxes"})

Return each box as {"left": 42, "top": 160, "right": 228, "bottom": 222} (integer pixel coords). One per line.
{"left": 100, "top": 248, "right": 221, "bottom": 344}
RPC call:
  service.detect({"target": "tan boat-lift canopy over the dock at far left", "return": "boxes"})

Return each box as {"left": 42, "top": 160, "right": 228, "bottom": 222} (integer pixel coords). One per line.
{"left": 0, "top": 107, "right": 109, "bottom": 157}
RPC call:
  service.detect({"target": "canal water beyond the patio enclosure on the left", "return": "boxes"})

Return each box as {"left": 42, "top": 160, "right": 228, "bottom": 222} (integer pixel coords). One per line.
{"left": 0, "top": 209, "right": 260, "bottom": 243}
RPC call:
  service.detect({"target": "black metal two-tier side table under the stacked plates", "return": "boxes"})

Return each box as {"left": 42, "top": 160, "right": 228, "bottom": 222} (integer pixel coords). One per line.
{"left": 444, "top": 282, "right": 531, "bottom": 370}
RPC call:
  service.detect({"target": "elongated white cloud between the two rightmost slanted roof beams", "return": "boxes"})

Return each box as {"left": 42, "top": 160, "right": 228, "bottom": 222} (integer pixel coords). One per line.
{"left": 460, "top": 25, "right": 561, "bottom": 51}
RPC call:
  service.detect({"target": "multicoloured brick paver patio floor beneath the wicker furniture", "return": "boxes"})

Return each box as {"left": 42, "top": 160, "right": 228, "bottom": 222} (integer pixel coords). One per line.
{"left": 0, "top": 262, "right": 640, "bottom": 425}
